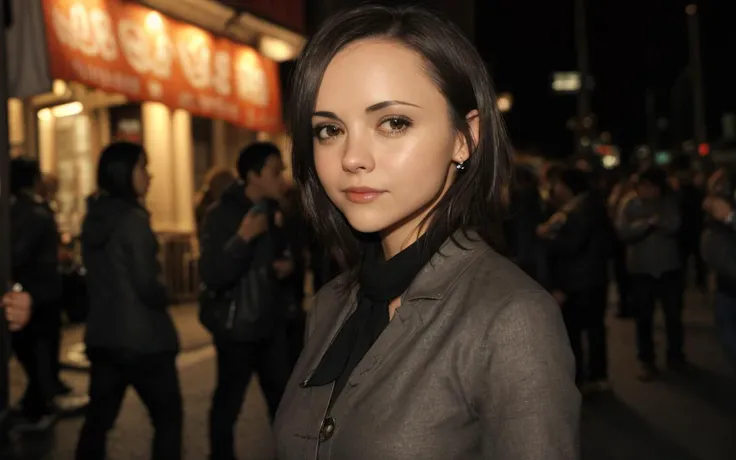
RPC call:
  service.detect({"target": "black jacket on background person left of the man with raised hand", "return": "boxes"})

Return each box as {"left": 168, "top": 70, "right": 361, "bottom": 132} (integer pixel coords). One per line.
{"left": 82, "top": 193, "right": 179, "bottom": 354}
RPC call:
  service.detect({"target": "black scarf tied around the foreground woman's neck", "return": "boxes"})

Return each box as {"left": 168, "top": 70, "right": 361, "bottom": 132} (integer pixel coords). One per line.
{"left": 307, "top": 237, "right": 439, "bottom": 406}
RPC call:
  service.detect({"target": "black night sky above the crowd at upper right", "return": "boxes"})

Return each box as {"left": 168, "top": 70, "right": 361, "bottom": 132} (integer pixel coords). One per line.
{"left": 478, "top": 0, "right": 736, "bottom": 156}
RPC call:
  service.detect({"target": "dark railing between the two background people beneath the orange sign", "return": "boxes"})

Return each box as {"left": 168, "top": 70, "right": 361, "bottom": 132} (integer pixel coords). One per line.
{"left": 158, "top": 233, "right": 199, "bottom": 303}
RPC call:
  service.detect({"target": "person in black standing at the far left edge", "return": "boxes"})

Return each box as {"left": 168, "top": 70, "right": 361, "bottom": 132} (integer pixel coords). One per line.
{"left": 10, "top": 157, "right": 61, "bottom": 429}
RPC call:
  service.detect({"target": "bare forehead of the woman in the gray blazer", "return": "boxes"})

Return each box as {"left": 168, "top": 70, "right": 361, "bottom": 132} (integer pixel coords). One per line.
{"left": 317, "top": 40, "right": 444, "bottom": 111}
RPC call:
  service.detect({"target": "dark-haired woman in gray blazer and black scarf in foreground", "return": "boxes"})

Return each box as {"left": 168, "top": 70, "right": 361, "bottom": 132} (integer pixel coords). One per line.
{"left": 275, "top": 6, "right": 580, "bottom": 460}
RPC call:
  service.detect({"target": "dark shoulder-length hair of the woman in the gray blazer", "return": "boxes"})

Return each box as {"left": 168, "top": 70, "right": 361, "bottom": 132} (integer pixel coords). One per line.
{"left": 289, "top": 5, "right": 511, "bottom": 267}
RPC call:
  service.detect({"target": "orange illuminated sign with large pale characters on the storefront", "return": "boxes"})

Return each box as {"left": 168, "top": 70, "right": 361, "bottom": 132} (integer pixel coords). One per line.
{"left": 42, "top": 0, "right": 282, "bottom": 132}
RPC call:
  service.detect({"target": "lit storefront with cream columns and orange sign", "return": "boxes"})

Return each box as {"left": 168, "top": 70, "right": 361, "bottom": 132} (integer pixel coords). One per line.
{"left": 9, "top": 0, "right": 299, "bottom": 235}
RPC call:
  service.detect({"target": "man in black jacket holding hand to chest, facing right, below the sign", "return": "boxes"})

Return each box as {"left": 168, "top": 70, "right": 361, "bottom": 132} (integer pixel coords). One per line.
{"left": 200, "top": 143, "right": 294, "bottom": 460}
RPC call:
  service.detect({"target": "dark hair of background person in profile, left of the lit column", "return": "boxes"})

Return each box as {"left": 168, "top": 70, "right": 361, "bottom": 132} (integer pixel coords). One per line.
{"left": 97, "top": 142, "right": 146, "bottom": 202}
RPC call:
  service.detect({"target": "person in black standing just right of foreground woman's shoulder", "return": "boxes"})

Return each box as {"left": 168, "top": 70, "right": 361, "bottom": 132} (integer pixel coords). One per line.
{"left": 537, "top": 169, "right": 610, "bottom": 392}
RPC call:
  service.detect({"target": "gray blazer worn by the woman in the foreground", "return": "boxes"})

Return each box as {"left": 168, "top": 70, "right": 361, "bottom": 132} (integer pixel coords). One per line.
{"left": 275, "top": 234, "right": 580, "bottom": 460}
